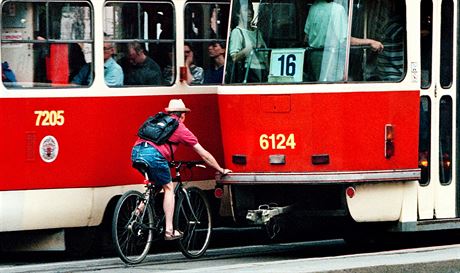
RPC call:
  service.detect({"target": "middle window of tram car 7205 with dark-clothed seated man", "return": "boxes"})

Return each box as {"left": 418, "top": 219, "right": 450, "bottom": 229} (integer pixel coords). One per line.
{"left": 104, "top": 1, "right": 176, "bottom": 86}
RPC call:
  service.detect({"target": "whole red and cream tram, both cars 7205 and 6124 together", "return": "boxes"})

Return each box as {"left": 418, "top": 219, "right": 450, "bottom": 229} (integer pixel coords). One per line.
{"left": 0, "top": 0, "right": 460, "bottom": 250}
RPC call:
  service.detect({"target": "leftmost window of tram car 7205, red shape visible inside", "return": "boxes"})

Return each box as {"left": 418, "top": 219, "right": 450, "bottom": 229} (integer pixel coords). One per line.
{"left": 1, "top": 0, "right": 94, "bottom": 89}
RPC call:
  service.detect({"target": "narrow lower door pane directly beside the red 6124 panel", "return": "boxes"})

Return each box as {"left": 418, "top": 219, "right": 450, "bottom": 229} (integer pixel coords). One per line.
{"left": 418, "top": 96, "right": 431, "bottom": 186}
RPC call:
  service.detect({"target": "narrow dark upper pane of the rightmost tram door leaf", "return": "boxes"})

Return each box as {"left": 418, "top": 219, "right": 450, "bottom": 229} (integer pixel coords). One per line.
{"left": 439, "top": 0, "right": 454, "bottom": 88}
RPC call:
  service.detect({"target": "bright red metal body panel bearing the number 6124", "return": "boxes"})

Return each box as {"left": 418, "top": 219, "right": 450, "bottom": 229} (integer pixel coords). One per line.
{"left": 219, "top": 91, "right": 419, "bottom": 172}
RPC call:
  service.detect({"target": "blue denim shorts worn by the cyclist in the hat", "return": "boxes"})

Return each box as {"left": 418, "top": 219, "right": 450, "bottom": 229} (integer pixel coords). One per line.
{"left": 131, "top": 142, "right": 172, "bottom": 186}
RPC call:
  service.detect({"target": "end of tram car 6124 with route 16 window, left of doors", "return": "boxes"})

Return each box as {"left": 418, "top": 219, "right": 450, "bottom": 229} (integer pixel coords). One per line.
{"left": 218, "top": 0, "right": 420, "bottom": 228}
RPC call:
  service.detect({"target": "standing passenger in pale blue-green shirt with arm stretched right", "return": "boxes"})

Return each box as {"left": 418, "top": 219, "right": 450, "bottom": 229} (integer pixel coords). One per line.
{"left": 304, "top": 0, "right": 383, "bottom": 81}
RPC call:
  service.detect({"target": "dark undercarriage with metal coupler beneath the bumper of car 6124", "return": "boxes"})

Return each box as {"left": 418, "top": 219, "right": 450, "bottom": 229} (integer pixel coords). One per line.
{"left": 228, "top": 185, "right": 349, "bottom": 239}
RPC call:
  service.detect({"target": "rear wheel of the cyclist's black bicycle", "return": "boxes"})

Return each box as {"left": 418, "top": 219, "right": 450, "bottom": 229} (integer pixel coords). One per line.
{"left": 112, "top": 191, "right": 154, "bottom": 264}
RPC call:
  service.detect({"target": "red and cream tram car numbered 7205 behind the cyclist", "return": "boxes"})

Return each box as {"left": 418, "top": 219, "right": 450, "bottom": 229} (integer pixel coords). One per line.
{"left": 0, "top": 0, "right": 230, "bottom": 253}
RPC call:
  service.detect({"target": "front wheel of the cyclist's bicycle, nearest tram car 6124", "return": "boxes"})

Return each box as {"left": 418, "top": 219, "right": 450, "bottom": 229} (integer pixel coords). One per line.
{"left": 175, "top": 187, "right": 212, "bottom": 258}
